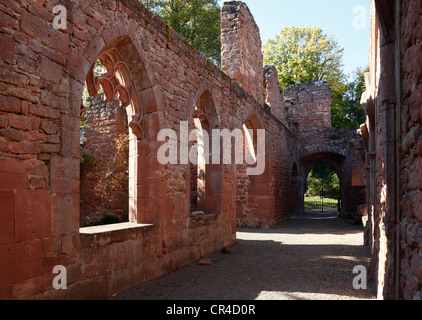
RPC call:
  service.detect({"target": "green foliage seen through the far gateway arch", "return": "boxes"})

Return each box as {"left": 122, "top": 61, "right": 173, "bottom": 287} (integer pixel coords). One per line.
{"left": 306, "top": 162, "right": 340, "bottom": 199}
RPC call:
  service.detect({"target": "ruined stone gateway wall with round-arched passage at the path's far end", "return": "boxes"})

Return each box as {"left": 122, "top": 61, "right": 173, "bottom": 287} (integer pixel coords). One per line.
{"left": 282, "top": 81, "right": 366, "bottom": 217}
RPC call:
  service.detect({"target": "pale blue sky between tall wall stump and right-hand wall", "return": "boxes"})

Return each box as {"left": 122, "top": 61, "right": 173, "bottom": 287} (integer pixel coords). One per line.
{"left": 220, "top": 0, "right": 371, "bottom": 79}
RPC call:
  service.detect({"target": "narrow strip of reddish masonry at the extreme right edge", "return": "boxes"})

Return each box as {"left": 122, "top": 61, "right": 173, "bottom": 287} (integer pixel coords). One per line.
{"left": 400, "top": 1, "right": 422, "bottom": 299}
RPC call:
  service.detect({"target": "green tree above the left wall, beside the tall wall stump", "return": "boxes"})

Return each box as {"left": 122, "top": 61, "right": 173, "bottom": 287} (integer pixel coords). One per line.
{"left": 140, "top": 0, "right": 221, "bottom": 65}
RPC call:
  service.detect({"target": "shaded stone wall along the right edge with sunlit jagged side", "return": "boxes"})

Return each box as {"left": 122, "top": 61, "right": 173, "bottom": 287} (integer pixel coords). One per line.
{"left": 361, "top": 0, "right": 422, "bottom": 299}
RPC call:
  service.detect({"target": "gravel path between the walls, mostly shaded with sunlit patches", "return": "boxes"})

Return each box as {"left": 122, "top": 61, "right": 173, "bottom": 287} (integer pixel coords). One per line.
{"left": 110, "top": 214, "right": 375, "bottom": 300}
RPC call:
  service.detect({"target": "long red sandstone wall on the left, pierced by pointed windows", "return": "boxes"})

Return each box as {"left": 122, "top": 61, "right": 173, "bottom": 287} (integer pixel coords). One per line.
{"left": 0, "top": 0, "right": 293, "bottom": 299}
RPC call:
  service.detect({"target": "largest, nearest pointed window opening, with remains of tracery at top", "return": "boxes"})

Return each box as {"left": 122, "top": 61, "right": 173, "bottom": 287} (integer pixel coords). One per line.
{"left": 80, "top": 48, "right": 136, "bottom": 227}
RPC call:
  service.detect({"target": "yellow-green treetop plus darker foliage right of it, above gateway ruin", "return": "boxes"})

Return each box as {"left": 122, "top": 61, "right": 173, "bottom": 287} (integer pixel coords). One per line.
{"left": 263, "top": 27, "right": 365, "bottom": 129}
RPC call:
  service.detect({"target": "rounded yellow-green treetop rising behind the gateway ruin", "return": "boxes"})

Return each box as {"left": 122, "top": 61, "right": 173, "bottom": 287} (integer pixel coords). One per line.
{"left": 263, "top": 26, "right": 345, "bottom": 92}
